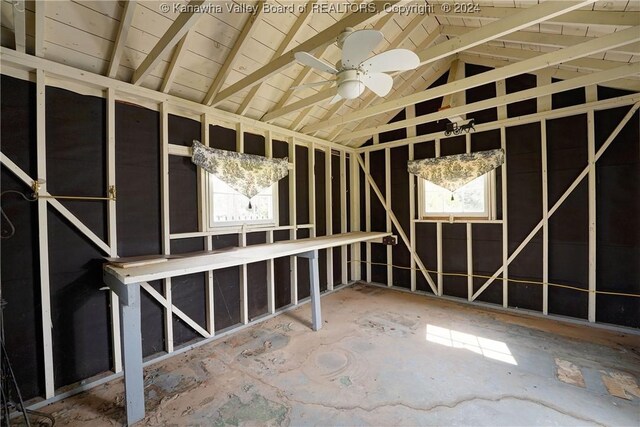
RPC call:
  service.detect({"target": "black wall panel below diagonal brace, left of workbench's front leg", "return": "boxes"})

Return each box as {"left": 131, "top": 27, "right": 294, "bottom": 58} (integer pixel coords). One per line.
{"left": 48, "top": 208, "right": 111, "bottom": 387}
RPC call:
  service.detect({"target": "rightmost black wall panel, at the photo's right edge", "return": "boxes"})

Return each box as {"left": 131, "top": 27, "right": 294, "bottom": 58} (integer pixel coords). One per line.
{"left": 595, "top": 103, "right": 640, "bottom": 328}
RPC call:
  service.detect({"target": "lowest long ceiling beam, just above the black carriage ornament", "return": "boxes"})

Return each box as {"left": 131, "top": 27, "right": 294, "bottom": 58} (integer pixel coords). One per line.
{"left": 337, "top": 63, "right": 640, "bottom": 142}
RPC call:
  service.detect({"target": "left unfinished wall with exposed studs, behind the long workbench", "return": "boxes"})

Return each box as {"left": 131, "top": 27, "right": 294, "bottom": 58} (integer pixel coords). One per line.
{"left": 0, "top": 75, "right": 348, "bottom": 399}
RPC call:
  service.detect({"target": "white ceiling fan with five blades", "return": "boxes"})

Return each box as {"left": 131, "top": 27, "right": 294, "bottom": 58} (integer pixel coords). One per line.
{"left": 292, "top": 28, "right": 420, "bottom": 103}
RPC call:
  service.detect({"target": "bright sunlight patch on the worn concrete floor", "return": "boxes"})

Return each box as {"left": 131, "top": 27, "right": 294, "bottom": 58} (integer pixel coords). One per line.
{"left": 427, "top": 324, "right": 518, "bottom": 365}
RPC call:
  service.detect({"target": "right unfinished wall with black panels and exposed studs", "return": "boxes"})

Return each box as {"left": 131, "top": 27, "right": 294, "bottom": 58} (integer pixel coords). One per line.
{"left": 359, "top": 64, "right": 640, "bottom": 327}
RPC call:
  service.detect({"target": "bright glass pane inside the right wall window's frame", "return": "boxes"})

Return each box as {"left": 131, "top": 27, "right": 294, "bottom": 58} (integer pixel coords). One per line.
{"left": 423, "top": 175, "right": 487, "bottom": 215}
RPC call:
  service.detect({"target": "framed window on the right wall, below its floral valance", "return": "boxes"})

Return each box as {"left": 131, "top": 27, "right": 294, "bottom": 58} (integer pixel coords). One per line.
{"left": 418, "top": 171, "right": 495, "bottom": 219}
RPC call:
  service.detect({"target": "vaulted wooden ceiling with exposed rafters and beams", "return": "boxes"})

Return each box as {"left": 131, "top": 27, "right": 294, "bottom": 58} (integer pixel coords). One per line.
{"left": 1, "top": 0, "right": 640, "bottom": 146}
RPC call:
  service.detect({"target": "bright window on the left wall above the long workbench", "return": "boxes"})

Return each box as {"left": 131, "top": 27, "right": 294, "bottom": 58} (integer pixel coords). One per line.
{"left": 207, "top": 174, "right": 278, "bottom": 228}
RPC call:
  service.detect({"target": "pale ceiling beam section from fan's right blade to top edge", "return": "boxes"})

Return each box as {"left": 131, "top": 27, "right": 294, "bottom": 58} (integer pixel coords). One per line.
{"left": 418, "top": 0, "right": 595, "bottom": 64}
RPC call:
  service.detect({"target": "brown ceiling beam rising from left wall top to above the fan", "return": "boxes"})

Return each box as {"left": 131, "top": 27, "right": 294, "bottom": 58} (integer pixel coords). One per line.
{"left": 211, "top": 0, "right": 402, "bottom": 106}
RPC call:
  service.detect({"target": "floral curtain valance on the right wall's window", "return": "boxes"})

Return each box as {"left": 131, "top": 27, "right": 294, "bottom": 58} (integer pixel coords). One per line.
{"left": 407, "top": 149, "right": 504, "bottom": 191}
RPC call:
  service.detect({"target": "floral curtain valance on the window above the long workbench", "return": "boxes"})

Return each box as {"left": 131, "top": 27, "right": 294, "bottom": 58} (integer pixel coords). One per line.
{"left": 191, "top": 140, "right": 289, "bottom": 199}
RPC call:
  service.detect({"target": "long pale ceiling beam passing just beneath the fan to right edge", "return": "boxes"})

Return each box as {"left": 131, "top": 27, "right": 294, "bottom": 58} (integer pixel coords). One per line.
{"left": 302, "top": 26, "right": 640, "bottom": 133}
